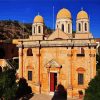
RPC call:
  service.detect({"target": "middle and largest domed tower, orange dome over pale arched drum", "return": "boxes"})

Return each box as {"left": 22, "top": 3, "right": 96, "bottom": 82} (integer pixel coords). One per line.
{"left": 56, "top": 8, "right": 72, "bottom": 33}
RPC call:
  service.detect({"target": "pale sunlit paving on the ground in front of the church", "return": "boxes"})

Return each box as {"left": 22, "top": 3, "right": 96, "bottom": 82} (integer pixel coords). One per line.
{"left": 30, "top": 94, "right": 82, "bottom": 100}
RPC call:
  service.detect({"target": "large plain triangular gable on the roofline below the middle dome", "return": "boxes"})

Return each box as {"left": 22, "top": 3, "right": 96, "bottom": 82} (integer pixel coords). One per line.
{"left": 47, "top": 29, "right": 70, "bottom": 40}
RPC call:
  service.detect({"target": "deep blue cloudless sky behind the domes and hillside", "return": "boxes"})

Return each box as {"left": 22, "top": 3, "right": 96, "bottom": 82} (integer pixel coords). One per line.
{"left": 0, "top": 0, "right": 100, "bottom": 38}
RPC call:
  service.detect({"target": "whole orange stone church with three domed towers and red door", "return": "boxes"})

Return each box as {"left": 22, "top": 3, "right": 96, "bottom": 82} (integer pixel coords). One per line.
{"left": 18, "top": 8, "right": 96, "bottom": 96}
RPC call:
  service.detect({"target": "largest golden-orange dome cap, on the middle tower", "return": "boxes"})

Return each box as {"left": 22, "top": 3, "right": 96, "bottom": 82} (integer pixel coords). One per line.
{"left": 57, "top": 8, "right": 71, "bottom": 19}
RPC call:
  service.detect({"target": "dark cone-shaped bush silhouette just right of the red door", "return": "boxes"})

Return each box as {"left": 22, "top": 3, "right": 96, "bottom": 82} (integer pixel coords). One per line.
{"left": 52, "top": 84, "right": 67, "bottom": 100}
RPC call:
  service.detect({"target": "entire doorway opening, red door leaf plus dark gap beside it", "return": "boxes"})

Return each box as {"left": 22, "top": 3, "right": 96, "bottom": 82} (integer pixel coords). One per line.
{"left": 50, "top": 73, "right": 57, "bottom": 92}
